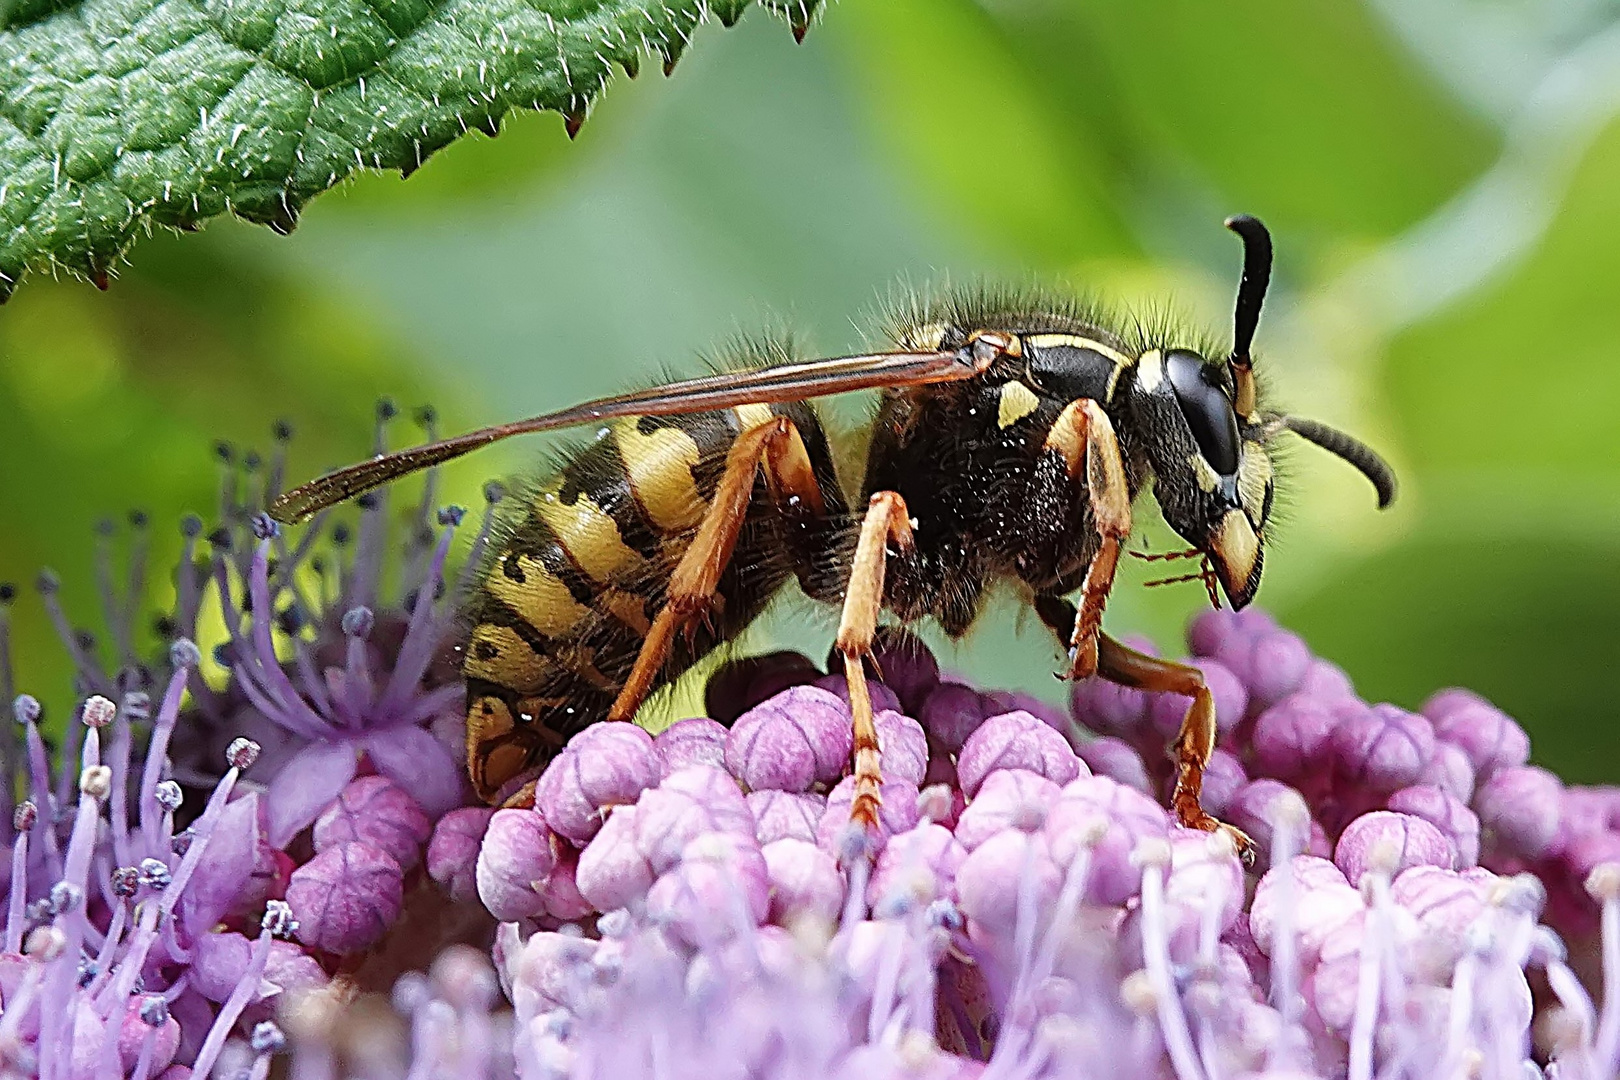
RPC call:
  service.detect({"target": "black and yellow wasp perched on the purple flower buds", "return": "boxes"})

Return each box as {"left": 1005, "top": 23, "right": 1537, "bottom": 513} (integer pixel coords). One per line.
{"left": 271, "top": 215, "right": 1395, "bottom": 847}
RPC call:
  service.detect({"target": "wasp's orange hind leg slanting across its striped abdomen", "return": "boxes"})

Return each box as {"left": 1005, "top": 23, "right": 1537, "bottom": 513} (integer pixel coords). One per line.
{"left": 608, "top": 416, "right": 823, "bottom": 721}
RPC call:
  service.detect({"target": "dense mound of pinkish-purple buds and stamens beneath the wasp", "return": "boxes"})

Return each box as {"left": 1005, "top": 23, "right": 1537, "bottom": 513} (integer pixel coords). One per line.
{"left": 411, "top": 612, "right": 1620, "bottom": 1080}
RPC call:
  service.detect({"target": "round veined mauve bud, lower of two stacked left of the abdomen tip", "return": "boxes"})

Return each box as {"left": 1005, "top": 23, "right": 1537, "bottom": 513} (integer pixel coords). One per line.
{"left": 287, "top": 840, "right": 405, "bottom": 954}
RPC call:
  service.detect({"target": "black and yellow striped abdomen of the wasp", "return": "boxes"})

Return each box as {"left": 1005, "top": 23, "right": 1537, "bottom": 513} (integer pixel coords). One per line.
{"left": 462, "top": 403, "right": 844, "bottom": 800}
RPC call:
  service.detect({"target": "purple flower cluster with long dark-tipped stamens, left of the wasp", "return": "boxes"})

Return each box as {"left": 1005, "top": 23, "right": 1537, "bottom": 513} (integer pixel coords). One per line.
{"left": 0, "top": 410, "right": 499, "bottom": 1080}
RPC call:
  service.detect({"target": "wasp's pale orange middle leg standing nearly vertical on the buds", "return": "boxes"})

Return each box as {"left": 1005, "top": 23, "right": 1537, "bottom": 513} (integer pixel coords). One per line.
{"left": 838, "top": 491, "right": 912, "bottom": 827}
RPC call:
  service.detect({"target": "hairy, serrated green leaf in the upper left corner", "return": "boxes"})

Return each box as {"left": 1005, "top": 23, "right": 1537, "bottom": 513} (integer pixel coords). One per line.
{"left": 0, "top": 0, "right": 818, "bottom": 298}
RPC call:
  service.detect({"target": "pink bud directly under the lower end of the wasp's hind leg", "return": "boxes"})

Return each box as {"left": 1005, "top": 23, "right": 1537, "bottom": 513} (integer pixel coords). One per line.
{"left": 535, "top": 721, "right": 659, "bottom": 844}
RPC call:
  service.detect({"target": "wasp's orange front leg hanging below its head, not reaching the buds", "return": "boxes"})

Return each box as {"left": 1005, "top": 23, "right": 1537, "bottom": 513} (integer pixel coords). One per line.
{"left": 1047, "top": 398, "right": 1131, "bottom": 678}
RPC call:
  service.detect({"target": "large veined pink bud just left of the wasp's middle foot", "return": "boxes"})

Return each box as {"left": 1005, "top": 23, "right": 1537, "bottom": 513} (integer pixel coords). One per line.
{"left": 726, "top": 687, "right": 852, "bottom": 792}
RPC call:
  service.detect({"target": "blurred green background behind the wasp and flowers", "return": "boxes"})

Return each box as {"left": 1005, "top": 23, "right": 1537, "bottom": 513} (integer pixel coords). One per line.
{"left": 0, "top": 0, "right": 1620, "bottom": 780}
